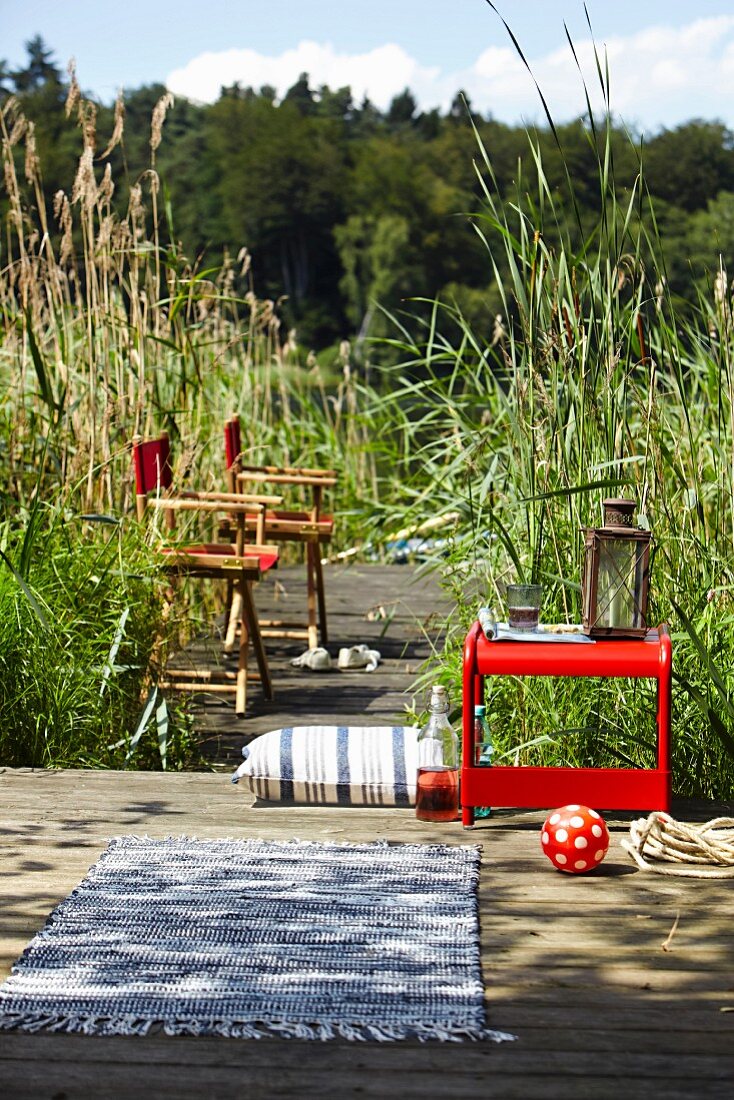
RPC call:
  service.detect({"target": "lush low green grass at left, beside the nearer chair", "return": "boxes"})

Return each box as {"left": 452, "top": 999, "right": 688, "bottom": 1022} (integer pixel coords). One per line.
{"left": 0, "top": 505, "right": 196, "bottom": 768}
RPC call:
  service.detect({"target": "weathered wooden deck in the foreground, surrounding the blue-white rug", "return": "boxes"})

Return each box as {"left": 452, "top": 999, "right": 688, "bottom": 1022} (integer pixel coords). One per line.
{"left": 0, "top": 770, "right": 734, "bottom": 1100}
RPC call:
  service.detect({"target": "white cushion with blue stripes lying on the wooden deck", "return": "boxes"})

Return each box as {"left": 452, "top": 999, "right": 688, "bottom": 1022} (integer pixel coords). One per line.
{"left": 232, "top": 726, "right": 418, "bottom": 806}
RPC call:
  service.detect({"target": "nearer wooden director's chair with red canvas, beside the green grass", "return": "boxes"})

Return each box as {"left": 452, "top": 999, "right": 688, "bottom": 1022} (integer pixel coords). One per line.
{"left": 132, "top": 433, "right": 282, "bottom": 717}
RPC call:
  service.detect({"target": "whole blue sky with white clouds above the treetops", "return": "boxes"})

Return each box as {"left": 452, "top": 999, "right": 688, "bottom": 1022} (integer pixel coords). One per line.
{"left": 0, "top": 0, "right": 734, "bottom": 132}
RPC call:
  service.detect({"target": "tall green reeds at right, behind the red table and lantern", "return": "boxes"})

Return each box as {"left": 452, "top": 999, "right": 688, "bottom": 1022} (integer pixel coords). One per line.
{"left": 374, "top": 38, "right": 734, "bottom": 798}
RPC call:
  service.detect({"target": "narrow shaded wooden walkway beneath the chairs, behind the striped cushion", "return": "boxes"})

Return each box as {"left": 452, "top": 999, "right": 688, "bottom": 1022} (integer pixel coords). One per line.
{"left": 183, "top": 564, "right": 449, "bottom": 766}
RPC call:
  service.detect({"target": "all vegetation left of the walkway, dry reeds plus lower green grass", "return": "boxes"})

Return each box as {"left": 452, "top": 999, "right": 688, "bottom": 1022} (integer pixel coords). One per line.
{"left": 0, "top": 81, "right": 376, "bottom": 767}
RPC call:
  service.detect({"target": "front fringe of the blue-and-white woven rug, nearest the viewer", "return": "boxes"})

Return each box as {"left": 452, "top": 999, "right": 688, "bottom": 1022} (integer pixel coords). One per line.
{"left": 0, "top": 1012, "right": 517, "bottom": 1043}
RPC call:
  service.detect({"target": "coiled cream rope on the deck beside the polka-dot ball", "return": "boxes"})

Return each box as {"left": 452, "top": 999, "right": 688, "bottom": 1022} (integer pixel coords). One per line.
{"left": 621, "top": 811, "right": 734, "bottom": 879}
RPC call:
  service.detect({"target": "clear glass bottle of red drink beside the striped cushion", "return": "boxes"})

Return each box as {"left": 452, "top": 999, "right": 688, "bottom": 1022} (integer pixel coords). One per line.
{"left": 416, "top": 684, "right": 459, "bottom": 822}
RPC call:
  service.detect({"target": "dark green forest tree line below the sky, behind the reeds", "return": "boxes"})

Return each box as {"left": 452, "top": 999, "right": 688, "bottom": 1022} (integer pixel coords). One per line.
{"left": 0, "top": 36, "right": 734, "bottom": 350}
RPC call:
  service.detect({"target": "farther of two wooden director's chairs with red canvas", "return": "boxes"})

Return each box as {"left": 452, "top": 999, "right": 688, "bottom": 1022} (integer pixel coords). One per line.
{"left": 224, "top": 416, "right": 337, "bottom": 648}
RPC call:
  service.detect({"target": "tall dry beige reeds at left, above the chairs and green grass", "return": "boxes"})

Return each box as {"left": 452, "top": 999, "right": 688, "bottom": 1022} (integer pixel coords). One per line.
{"left": 0, "top": 88, "right": 374, "bottom": 525}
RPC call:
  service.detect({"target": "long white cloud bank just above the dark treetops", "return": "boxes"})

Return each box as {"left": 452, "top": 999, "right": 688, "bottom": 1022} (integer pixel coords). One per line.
{"left": 167, "top": 15, "right": 734, "bottom": 129}
